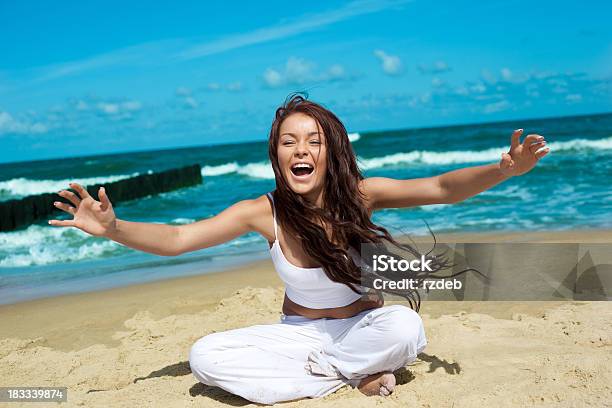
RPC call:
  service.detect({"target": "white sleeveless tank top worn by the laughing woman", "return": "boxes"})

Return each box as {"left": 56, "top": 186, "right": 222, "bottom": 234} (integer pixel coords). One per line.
{"left": 267, "top": 193, "right": 363, "bottom": 309}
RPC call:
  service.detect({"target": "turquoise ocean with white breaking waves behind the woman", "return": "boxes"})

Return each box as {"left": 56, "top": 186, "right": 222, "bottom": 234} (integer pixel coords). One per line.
{"left": 0, "top": 114, "right": 612, "bottom": 304}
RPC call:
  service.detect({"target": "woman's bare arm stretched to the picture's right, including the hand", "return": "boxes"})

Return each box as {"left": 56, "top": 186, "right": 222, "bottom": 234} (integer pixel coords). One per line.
{"left": 364, "top": 129, "right": 550, "bottom": 209}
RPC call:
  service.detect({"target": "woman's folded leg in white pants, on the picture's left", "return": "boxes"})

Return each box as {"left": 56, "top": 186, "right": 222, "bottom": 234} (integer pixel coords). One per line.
{"left": 189, "top": 322, "right": 347, "bottom": 404}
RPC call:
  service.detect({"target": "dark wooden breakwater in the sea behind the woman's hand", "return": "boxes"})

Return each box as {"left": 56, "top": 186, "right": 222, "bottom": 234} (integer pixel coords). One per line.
{"left": 0, "top": 164, "right": 202, "bottom": 232}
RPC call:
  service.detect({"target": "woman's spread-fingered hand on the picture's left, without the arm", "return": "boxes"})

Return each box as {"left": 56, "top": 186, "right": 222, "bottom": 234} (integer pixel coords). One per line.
{"left": 49, "top": 183, "right": 117, "bottom": 236}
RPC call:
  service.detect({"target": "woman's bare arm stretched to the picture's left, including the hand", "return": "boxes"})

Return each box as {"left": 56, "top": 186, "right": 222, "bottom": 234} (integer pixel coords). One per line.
{"left": 49, "top": 183, "right": 265, "bottom": 256}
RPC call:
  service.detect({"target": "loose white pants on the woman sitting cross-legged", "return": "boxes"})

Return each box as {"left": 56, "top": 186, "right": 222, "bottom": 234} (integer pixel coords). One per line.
{"left": 189, "top": 305, "right": 427, "bottom": 404}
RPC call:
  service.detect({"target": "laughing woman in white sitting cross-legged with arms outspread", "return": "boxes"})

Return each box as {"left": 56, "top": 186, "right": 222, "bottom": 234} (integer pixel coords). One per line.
{"left": 50, "top": 95, "right": 548, "bottom": 404}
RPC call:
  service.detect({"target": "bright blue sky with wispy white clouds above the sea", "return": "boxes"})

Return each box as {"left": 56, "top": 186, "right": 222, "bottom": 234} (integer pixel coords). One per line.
{"left": 0, "top": 0, "right": 612, "bottom": 162}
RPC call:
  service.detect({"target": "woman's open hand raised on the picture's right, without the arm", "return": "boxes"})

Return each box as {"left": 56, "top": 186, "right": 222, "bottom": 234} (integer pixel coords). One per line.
{"left": 499, "top": 129, "right": 550, "bottom": 176}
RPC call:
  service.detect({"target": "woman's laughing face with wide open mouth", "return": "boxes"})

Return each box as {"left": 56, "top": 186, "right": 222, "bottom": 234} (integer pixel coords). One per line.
{"left": 277, "top": 113, "right": 327, "bottom": 205}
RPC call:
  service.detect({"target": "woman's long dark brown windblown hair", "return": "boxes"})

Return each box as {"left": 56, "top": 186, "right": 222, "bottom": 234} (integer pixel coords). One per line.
{"left": 268, "top": 93, "right": 478, "bottom": 312}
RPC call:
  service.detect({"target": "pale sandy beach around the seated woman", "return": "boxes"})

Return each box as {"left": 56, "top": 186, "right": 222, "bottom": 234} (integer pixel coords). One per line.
{"left": 0, "top": 231, "right": 612, "bottom": 408}
